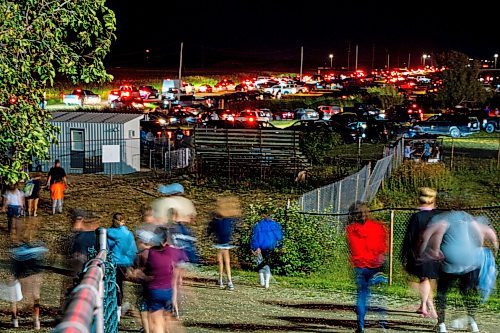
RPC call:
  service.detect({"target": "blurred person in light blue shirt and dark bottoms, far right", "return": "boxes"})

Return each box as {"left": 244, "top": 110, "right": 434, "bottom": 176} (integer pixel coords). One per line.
{"left": 420, "top": 211, "right": 498, "bottom": 333}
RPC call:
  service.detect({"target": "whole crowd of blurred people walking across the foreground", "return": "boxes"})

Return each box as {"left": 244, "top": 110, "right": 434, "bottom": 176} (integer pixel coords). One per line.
{"left": 0, "top": 161, "right": 498, "bottom": 333}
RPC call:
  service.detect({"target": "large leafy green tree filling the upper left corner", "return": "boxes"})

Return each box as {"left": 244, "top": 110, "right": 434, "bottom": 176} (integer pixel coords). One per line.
{"left": 0, "top": 0, "right": 116, "bottom": 184}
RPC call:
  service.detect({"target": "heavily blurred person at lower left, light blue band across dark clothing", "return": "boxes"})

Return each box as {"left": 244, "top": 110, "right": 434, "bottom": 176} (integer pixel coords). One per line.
{"left": 11, "top": 217, "right": 48, "bottom": 330}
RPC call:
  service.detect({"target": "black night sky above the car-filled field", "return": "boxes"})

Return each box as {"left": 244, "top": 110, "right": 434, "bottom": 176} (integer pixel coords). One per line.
{"left": 107, "top": 0, "right": 500, "bottom": 69}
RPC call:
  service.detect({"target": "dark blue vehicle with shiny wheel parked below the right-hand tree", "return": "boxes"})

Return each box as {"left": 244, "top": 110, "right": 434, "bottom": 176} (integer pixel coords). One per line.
{"left": 413, "top": 114, "right": 480, "bottom": 138}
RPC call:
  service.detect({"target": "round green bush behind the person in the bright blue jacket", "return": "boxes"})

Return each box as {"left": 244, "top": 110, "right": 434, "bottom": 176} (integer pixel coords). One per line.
{"left": 238, "top": 203, "right": 346, "bottom": 276}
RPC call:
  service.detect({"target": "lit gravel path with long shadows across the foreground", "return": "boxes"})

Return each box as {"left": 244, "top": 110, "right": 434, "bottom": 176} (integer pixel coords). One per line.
{"left": 121, "top": 272, "right": 500, "bottom": 333}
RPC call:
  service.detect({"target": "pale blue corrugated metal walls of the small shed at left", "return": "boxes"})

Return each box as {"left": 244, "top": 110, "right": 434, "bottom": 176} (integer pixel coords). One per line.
{"left": 40, "top": 120, "right": 140, "bottom": 174}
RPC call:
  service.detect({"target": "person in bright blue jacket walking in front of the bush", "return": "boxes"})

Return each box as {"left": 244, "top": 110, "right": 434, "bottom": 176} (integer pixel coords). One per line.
{"left": 250, "top": 214, "right": 284, "bottom": 289}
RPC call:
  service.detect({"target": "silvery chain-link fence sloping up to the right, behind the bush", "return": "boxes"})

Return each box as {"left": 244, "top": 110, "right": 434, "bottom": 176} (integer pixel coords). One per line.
{"left": 298, "top": 140, "right": 404, "bottom": 214}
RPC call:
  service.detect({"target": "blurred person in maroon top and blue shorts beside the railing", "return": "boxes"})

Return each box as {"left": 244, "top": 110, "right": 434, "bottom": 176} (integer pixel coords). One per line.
{"left": 144, "top": 224, "right": 188, "bottom": 333}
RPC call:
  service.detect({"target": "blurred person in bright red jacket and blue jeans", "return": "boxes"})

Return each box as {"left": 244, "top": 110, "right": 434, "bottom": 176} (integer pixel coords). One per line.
{"left": 346, "top": 202, "right": 388, "bottom": 333}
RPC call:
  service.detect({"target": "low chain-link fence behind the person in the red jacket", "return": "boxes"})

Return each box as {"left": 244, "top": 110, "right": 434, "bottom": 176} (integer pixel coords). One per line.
{"left": 296, "top": 206, "right": 500, "bottom": 300}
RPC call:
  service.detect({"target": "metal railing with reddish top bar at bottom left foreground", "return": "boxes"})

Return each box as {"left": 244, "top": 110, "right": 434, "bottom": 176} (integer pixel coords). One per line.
{"left": 54, "top": 228, "right": 118, "bottom": 333}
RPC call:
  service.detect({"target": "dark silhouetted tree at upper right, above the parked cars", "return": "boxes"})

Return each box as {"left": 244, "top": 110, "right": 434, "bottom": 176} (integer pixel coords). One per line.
{"left": 436, "top": 51, "right": 488, "bottom": 107}
